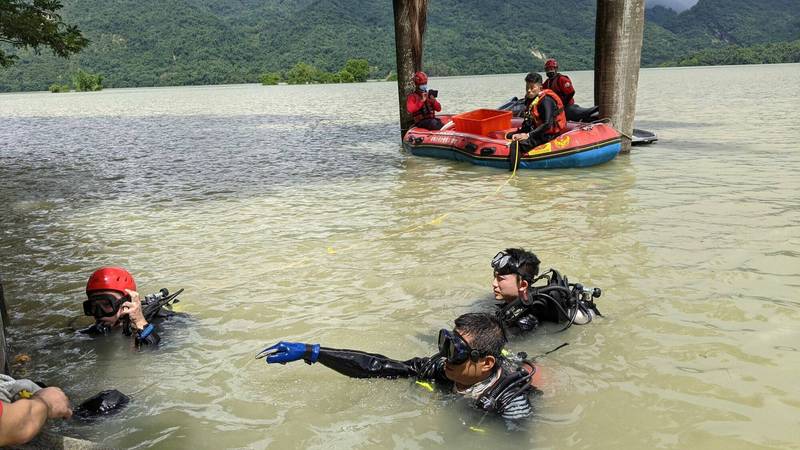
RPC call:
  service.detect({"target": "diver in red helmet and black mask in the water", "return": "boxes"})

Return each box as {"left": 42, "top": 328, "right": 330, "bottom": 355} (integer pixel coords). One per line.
{"left": 79, "top": 267, "right": 183, "bottom": 346}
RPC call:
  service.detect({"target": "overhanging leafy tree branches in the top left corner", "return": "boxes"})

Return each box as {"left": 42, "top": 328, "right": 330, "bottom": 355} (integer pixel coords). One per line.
{"left": 0, "top": 0, "right": 89, "bottom": 67}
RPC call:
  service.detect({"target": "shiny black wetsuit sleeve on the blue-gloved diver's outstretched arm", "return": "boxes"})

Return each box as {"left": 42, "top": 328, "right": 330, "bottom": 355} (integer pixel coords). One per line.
{"left": 317, "top": 347, "right": 447, "bottom": 381}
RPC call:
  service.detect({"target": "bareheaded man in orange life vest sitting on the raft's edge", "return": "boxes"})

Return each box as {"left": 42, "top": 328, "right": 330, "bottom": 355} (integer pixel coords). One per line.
{"left": 506, "top": 73, "right": 567, "bottom": 152}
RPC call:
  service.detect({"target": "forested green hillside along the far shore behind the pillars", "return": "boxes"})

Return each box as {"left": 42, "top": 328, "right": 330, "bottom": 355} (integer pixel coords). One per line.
{"left": 0, "top": 0, "right": 800, "bottom": 91}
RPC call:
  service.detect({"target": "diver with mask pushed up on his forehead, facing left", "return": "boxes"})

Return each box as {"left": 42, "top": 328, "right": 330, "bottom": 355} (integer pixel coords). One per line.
{"left": 492, "top": 248, "right": 601, "bottom": 333}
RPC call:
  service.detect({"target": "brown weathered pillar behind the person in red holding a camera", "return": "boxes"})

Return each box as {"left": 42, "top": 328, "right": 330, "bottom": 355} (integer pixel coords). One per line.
{"left": 392, "top": 0, "right": 428, "bottom": 138}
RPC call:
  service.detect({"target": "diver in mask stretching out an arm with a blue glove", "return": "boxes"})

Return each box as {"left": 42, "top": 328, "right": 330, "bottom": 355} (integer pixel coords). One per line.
{"left": 256, "top": 313, "right": 538, "bottom": 421}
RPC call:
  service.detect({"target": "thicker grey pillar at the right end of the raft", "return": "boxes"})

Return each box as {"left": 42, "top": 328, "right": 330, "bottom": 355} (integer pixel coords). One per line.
{"left": 594, "top": 0, "right": 644, "bottom": 153}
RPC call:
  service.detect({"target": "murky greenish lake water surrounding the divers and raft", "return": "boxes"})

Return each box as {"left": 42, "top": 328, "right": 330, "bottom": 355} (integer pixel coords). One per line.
{"left": 0, "top": 64, "right": 800, "bottom": 450}
